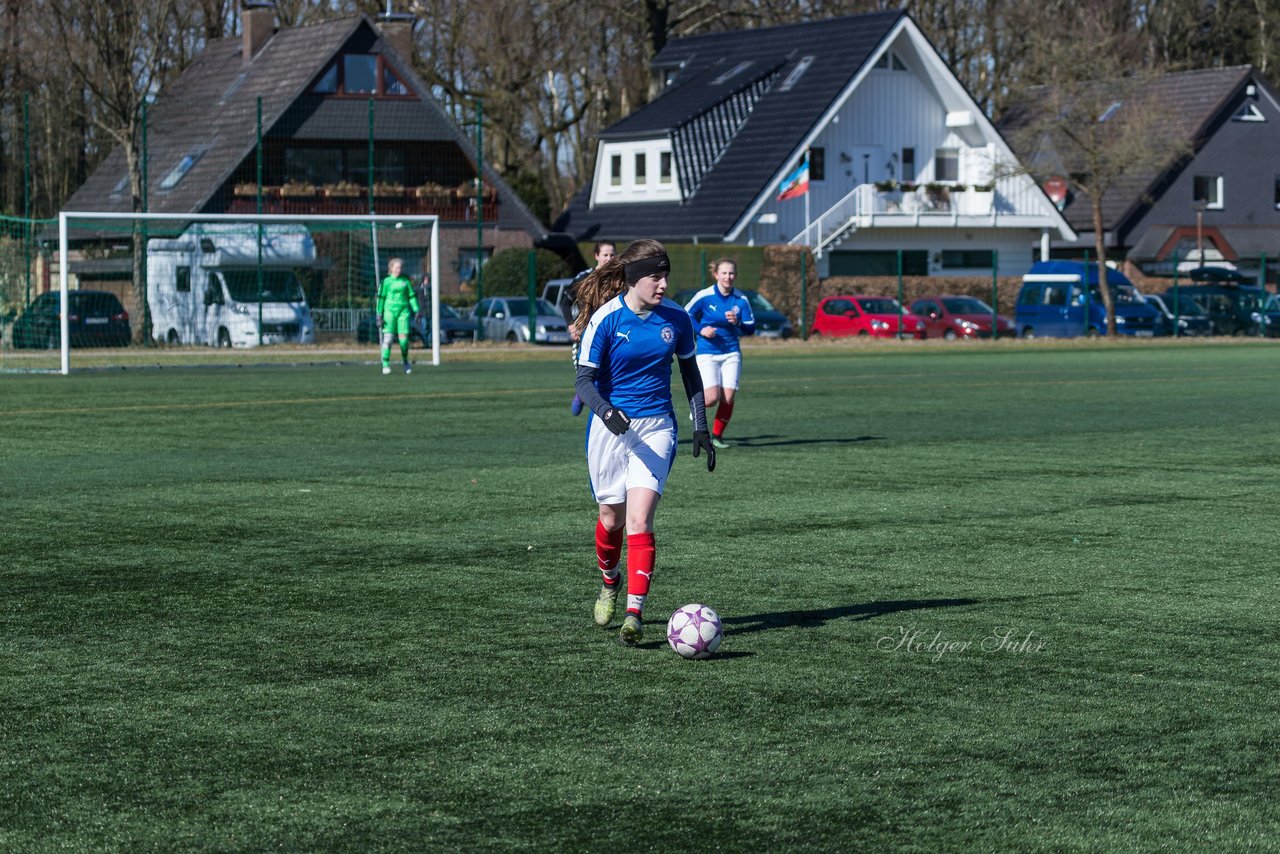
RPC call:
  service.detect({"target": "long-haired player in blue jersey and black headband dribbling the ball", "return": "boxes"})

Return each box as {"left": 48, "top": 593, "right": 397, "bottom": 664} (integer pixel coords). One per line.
{"left": 575, "top": 239, "right": 716, "bottom": 647}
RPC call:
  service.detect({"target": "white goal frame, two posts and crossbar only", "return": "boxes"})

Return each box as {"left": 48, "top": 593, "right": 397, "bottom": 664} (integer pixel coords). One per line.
{"left": 58, "top": 210, "right": 440, "bottom": 375}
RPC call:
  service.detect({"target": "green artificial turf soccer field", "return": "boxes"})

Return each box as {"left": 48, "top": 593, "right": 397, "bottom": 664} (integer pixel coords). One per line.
{"left": 0, "top": 342, "right": 1280, "bottom": 851}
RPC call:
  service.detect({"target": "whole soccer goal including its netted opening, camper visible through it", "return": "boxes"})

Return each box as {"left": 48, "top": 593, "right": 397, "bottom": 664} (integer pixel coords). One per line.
{"left": 51, "top": 211, "right": 440, "bottom": 374}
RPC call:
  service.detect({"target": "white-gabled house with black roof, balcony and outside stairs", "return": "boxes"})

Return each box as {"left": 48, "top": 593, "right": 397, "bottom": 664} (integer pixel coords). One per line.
{"left": 556, "top": 12, "right": 1075, "bottom": 275}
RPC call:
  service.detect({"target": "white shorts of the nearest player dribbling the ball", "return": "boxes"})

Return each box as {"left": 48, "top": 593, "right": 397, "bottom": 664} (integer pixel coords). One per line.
{"left": 586, "top": 414, "right": 676, "bottom": 504}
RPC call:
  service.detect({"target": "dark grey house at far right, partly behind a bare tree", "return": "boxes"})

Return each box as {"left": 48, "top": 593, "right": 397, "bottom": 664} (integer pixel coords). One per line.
{"left": 1000, "top": 65, "right": 1280, "bottom": 279}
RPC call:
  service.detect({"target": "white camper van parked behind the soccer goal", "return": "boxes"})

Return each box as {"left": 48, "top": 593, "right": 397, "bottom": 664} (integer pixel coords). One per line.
{"left": 147, "top": 223, "right": 316, "bottom": 347}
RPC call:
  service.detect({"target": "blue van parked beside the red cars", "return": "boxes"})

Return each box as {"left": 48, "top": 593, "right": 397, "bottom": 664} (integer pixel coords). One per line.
{"left": 1014, "top": 261, "right": 1160, "bottom": 338}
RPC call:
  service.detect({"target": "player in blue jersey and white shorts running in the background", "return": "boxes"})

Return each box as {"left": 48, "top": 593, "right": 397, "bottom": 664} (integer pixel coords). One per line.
{"left": 685, "top": 257, "right": 755, "bottom": 449}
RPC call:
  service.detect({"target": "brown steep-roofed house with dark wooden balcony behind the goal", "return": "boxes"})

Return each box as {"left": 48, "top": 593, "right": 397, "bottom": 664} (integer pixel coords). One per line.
{"left": 65, "top": 1, "right": 547, "bottom": 293}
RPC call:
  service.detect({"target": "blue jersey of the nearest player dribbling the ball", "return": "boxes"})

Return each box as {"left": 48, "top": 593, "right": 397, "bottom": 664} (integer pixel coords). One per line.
{"left": 577, "top": 297, "right": 694, "bottom": 417}
